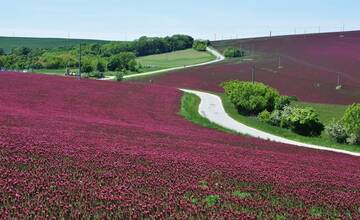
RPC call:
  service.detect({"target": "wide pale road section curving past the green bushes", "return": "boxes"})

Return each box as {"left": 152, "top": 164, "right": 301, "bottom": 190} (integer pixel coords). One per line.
{"left": 180, "top": 89, "right": 360, "bottom": 156}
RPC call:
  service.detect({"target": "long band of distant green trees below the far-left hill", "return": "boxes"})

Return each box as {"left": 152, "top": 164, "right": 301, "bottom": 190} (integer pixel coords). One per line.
{"left": 0, "top": 35, "right": 194, "bottom": 72}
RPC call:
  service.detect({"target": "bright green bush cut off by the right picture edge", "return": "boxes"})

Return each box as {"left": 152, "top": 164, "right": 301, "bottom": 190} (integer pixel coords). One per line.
{"left": 342, "top": 104, "right": 360, "bottom": 136}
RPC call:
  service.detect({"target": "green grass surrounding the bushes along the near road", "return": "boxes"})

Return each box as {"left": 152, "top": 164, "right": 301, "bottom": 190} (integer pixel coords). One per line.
{"left": 219, "top": 94, "right": 360, "bottom": 152}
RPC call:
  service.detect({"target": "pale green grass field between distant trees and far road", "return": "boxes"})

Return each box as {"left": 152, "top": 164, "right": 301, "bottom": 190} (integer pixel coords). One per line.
{"left": 136, "top": 49, "right": 214, "bottom": 72}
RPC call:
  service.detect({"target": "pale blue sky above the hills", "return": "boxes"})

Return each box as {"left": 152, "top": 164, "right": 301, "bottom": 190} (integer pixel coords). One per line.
{"left": 0, "top": 0, "right": 360, "bottom": 40}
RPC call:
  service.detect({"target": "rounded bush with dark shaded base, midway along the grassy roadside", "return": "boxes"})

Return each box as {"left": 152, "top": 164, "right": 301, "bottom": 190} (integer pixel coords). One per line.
{"left": 281, "top": 107, "right": 324, "bottom": 136}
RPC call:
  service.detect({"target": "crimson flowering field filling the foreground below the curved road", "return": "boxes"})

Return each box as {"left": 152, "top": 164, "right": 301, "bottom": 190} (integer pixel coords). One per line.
{"left": 0, "top": 73, "right": 360, "bottom": 219}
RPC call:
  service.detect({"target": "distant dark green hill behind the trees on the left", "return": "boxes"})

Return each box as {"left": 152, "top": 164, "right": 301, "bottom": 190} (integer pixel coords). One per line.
{"left": 0, "top": 37, "right": 109, "bottom": 52}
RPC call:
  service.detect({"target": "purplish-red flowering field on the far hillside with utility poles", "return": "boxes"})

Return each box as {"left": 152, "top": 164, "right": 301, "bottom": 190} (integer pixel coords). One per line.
{"left": 139, "top": 31, "right": 360, "bottom": 104}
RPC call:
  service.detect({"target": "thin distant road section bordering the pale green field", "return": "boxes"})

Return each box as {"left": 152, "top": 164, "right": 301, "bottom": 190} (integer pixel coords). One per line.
{"left": 100, "top": 47, "right": 225, "bottom": 80}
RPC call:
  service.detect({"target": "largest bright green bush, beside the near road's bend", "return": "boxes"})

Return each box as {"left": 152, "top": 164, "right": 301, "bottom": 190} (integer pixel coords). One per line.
{"left": 221, "top": 80, "right": 280, "bottom": 115}
